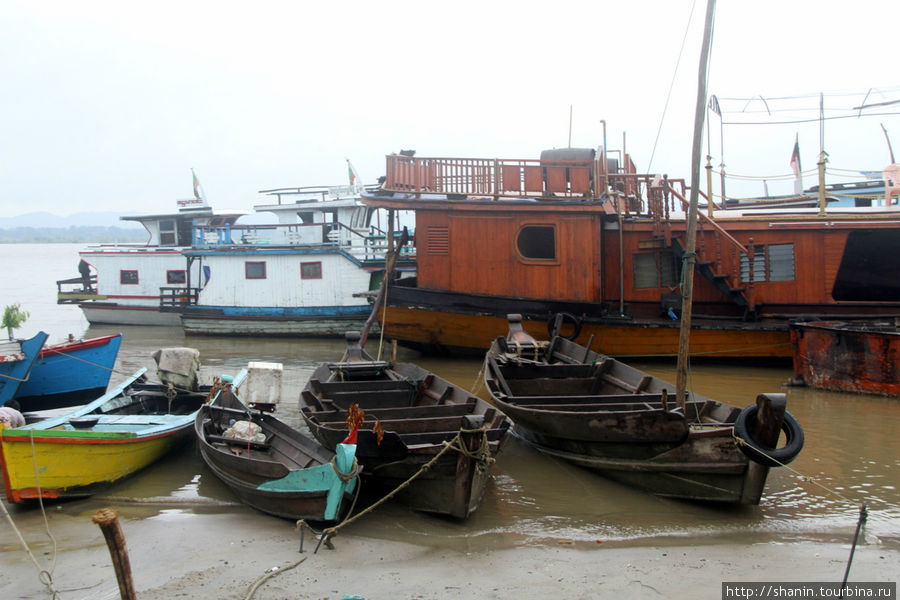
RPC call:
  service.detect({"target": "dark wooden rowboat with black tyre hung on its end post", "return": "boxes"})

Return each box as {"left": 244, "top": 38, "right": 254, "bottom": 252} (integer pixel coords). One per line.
{"left": 484, "top": 315, "right": 803, "bottom": 504}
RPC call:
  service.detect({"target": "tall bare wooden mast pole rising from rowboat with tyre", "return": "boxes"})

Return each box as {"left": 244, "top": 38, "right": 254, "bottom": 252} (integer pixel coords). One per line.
{"left": 675, "top": 0, "right": 724, "bottom": 407}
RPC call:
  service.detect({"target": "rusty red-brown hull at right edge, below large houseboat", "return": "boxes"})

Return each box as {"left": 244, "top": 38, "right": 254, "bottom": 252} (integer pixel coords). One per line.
{"left": 791, "top": 319, "right": 900, "bottom": 396}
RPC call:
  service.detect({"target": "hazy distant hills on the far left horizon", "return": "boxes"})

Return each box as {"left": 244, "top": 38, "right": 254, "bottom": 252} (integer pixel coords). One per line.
{"left": 0, "top": 211, "right": 147, "bottom": 244}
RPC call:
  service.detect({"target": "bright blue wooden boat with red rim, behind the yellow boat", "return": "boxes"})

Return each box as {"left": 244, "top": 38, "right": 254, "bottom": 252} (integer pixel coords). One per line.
{"left": 16, "top": 333, "right": 122, "bottom": 410}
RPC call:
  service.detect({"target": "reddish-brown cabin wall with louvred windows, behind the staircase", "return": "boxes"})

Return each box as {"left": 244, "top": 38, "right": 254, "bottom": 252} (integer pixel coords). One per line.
{"left": 602, "top": 220, "right": 900, "bottom": 316}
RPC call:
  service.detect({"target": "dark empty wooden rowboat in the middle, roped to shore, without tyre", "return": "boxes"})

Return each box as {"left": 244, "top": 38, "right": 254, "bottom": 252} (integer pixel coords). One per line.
{"left": 301, "top": 332, "right": 509, "bottom": 519}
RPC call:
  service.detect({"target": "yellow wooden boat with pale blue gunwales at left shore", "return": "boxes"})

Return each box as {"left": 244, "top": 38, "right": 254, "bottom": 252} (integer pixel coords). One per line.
{"left": 0, "top": 369, "right": 239, "bottom": 502}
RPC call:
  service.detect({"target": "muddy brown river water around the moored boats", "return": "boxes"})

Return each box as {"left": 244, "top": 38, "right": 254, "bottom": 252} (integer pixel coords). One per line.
{"left": 0, "top": 244, "right": 900, "bottom": 549}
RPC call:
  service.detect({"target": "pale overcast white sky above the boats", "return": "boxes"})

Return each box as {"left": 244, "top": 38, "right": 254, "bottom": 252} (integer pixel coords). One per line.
{"left": 0, "top": 0, "right": 900, "bottom": 216}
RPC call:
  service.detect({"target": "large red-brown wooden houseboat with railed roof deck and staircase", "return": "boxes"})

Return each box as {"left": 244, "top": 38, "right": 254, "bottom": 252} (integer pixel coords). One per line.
{"left": 363, "top": 149, "right": 900, "bottom": 360}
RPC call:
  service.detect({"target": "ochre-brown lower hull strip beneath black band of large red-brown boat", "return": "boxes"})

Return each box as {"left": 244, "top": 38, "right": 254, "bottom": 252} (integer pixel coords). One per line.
{"left": 379, "top": 302, "right": 791, "bottom": 359}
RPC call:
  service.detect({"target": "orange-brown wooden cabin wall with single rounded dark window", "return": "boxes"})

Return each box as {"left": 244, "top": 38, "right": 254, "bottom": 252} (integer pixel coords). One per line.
{"left": 416, "top": 210, "right": 600, "bottom": 302}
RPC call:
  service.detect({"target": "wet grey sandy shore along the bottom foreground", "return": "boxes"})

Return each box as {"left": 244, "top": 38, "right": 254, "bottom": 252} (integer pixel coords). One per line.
{"left": 0, "top": 504, "right": 900, "bottom": 600}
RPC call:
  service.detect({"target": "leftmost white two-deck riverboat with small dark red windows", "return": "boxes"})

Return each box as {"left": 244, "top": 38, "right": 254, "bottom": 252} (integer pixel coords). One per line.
{"left": 56, "top": 189, "right": 247, "bottom": 326}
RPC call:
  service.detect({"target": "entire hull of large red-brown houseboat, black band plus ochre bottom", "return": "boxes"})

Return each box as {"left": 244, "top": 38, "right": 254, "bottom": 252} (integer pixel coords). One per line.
{"left": 379, "top": 286, "right": 791, "bottom": 359}
